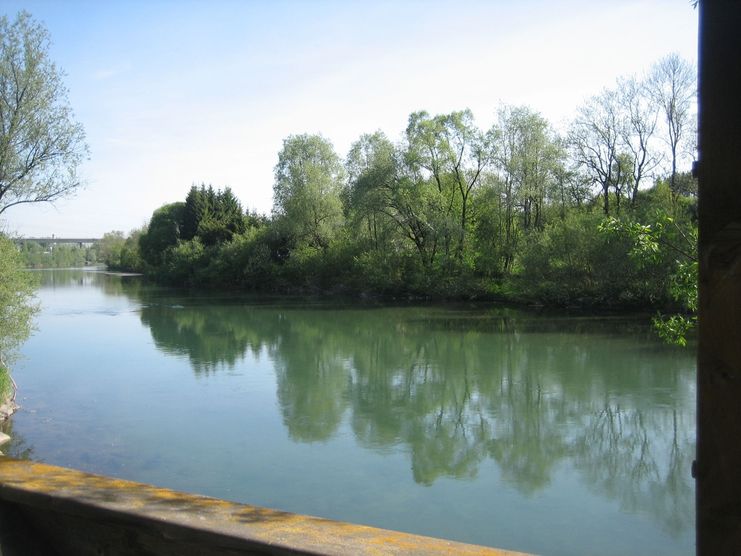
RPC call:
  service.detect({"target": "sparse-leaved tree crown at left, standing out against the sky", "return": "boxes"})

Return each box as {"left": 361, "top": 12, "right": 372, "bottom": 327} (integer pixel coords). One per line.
{"left": 0, "top": 12, "right": 88, "bottom": 214}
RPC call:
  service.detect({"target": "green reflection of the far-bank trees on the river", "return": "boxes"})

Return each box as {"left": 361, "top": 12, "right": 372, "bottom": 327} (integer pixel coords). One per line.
{"left": 118, "top": 280, "right": 695, "bottom": 534}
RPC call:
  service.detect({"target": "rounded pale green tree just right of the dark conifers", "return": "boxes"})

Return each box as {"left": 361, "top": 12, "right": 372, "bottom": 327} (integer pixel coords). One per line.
{"left": 273, "top": 134, "right": 344, "bottom": 251}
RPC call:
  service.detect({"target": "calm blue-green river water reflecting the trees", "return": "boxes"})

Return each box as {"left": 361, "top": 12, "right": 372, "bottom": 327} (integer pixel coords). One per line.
{"left": 6, "top": 270, "right": 695, "bottom": 555}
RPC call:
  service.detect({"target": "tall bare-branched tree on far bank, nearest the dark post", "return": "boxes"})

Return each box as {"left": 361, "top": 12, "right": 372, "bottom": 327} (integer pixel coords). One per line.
{"left": 649, "top": 53, "right": 697, "bottom": 194}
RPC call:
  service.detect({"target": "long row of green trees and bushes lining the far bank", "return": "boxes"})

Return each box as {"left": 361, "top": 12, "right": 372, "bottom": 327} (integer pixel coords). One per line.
{"left": 101, "top": 55, "right": 696, "bottom": 308}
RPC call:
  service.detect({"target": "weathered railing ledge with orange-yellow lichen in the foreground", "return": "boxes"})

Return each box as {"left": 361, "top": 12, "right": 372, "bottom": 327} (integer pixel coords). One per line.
{"left": 0, "top": 457, "right": 528, "bottom": 556}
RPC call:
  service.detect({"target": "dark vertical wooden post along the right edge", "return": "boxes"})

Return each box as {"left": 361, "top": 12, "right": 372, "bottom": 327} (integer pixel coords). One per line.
{"left": 693, "top": 0, "right": 741, "bottom": 555}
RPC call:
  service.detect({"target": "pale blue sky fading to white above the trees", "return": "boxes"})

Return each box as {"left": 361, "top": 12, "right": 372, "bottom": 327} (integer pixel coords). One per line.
{"left": 0, "top": 0, "right": 697, "bottom": 237}
